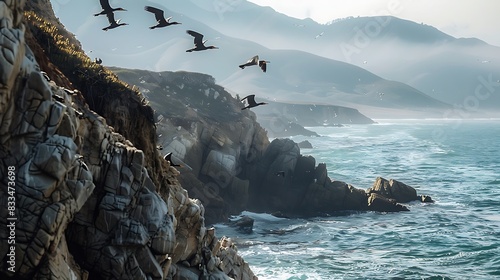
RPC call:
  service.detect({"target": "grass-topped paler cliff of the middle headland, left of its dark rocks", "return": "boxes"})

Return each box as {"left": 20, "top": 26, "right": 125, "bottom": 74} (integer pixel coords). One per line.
{"left": 113, "top": 69, "right": 269, "bottom": 222}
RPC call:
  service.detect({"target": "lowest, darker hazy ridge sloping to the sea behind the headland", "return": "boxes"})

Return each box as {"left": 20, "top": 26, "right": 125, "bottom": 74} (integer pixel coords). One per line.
{"left": 221, "top": 48, "right": 447, "bottom": 116}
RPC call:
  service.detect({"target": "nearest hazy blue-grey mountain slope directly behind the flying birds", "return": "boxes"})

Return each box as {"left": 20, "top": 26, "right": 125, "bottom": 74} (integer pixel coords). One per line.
{"left": 49, "top": 1, "right": 447, "bottom": 116}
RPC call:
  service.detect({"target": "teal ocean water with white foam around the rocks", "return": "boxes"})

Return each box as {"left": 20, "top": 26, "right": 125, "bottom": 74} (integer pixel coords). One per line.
{"left": 215, "top": 120, "right": 500, "bottom": 280}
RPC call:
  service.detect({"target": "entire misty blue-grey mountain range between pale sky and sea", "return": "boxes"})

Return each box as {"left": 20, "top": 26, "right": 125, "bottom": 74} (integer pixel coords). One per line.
{"left": 51, "top": 0, "right": 500, "bottom": 118}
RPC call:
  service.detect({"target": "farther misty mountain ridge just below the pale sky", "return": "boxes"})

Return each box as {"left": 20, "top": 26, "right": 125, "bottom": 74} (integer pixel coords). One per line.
{"left": 162, "top": 0, "right": 500, "bottom": 113}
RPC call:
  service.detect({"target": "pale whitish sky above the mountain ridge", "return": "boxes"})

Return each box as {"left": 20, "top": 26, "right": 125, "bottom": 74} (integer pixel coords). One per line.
{"left": 248, "top": 0, "right": 500, "bottom": 46}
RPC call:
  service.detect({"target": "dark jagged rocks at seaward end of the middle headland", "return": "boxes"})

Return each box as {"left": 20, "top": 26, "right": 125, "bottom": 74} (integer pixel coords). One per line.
{"left": 248, "top": 139, "right": 432, "bottom": 216}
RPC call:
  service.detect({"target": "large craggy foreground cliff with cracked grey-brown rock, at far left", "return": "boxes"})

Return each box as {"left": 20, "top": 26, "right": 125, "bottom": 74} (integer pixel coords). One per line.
{"left": 0, "top": 1, "right": 254, "bottom": 279}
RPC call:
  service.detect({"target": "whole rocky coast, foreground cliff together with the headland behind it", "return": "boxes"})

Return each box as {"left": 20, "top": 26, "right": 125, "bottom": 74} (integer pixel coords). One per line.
{"left": 0, "top": 0, "right": 430, "bottom": 279}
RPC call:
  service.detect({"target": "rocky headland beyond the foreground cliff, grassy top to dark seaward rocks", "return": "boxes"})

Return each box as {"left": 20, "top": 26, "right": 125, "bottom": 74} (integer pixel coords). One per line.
{"left": 113, "top": 71, "right": 432, "bottom": 222}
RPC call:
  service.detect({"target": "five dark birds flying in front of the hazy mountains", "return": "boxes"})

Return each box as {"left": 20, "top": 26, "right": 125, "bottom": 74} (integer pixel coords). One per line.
{"left": 94, "top": 0, "right": 270, "bottom": 110}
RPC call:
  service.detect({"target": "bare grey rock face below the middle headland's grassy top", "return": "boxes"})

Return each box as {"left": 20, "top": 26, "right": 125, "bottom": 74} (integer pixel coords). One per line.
{"left": 158, "top": 104, "right": 268, "bottom": 222}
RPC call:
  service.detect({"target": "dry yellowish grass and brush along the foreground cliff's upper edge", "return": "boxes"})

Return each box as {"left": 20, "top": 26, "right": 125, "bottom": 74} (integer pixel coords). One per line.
{"left": 24, "top": 11, "right": 147, "bottom": 113}
